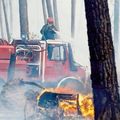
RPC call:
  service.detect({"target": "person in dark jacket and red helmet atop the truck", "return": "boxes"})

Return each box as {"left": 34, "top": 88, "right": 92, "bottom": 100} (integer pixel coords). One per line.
{"left": 40, "top": 17, "right": 57, "bottom": 40}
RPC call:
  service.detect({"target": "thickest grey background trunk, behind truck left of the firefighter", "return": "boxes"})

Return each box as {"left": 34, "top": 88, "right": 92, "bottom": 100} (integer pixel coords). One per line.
{"left": 19, "top": 0, "right": 29, "bottom": 40}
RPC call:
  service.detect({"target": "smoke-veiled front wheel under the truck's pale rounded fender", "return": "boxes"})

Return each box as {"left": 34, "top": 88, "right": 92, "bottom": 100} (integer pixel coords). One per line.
{"left": 57, "top": 77, "right": 85, "bottom": 93}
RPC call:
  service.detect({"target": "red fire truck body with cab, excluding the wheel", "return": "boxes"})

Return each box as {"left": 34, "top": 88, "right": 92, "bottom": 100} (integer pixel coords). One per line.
{"left": 0, "top": 40, "right": 86, "bottom": 88}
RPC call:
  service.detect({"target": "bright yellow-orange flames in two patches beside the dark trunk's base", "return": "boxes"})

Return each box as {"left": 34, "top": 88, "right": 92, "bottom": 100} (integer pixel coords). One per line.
{"left": 59, "top": 94, "right": 94, "bottom": 120}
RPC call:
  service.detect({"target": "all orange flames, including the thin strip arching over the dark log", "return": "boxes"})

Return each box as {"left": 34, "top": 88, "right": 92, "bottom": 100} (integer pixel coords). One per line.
{"left": 38, "top": 88, "right": 94, "bottom": 120}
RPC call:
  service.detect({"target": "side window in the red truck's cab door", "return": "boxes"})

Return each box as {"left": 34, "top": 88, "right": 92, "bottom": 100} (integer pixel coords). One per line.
{"left": 48, "top": 45, "right": 65, "bottom": 61}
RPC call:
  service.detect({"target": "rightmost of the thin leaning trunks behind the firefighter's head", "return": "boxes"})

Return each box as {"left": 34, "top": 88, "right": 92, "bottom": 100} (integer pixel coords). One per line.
{"left": 53, "top": 0, "right": 59, "bottom": 30}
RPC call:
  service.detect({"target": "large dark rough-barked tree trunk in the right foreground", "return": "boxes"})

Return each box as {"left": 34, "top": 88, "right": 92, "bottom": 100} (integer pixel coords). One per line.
{"left": 85, "top": 0, "right": 120, "bottom": 120}
